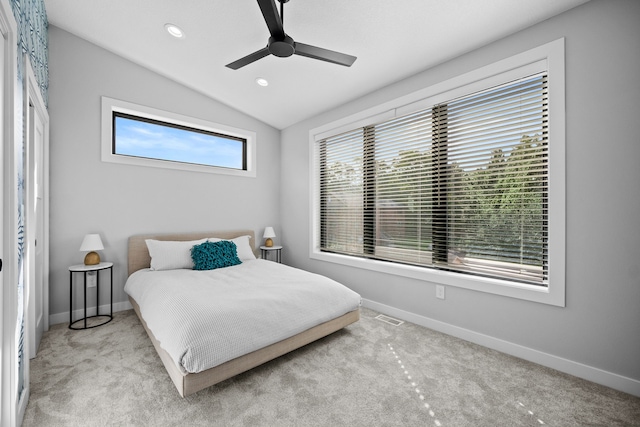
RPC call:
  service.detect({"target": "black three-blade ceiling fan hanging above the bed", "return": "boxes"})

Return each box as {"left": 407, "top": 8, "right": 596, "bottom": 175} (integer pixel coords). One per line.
{"left": 227, "top": 0, "right": 357, "bottom": 70}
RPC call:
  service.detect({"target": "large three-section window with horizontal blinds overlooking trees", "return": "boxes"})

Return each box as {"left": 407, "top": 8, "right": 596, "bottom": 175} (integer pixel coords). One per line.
{"left": 313, "top": 40, "right": 564, "bottom": 305}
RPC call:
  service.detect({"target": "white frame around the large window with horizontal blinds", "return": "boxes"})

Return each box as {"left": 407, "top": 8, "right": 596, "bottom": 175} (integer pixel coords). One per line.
{"left": 309, "top": 38, "right": 566, "bottom": 307}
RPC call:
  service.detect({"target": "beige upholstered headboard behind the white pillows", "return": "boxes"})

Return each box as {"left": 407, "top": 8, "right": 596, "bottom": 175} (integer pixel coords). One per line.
{"left": 127, "top": 230, "right": 256, "bottom": 276}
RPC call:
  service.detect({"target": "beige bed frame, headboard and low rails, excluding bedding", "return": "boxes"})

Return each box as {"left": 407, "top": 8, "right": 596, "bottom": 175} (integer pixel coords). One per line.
{"left": 128, "top": 230, "right": 360, "bottom": 397}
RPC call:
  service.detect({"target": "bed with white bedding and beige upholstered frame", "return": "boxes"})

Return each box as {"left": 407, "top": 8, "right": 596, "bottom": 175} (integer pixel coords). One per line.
{"left": 125, "top": 230, "right": 360, "bottom": 397}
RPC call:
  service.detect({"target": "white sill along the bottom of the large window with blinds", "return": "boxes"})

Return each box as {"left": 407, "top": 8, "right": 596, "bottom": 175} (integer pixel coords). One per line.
{"left": 310, "top": 250, "right": 565, "bottom": 307}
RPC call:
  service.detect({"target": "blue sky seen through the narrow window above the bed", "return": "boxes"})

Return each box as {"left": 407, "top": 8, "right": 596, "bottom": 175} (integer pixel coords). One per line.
{"left": 113, "top": 115, "right": 245, "bottom": 170}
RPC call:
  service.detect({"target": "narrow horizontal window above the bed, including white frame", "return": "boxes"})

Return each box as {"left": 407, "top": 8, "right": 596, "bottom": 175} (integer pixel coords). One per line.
{"left": 102, "top": 97, "right": 255, "bottom": 176}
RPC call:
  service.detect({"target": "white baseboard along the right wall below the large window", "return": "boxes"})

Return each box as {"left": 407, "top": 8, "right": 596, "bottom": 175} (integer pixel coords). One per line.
{"left": 362, "top": 299, "right": 640, "bottom": 396}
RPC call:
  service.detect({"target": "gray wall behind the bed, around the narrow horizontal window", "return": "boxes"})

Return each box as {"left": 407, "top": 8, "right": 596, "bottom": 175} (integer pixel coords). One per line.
{"left": 49, "top": 26, "right": 280, "bottom": 323}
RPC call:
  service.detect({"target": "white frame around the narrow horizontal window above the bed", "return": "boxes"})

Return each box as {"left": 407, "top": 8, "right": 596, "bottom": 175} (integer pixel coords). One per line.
{"left": 101, "top": 96, "right": 256, "bottom": 178}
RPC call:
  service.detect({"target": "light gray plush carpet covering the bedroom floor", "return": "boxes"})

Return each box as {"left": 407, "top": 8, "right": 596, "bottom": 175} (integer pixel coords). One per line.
{"left": 23, "top": 309, "right": 640, "bottom": 427}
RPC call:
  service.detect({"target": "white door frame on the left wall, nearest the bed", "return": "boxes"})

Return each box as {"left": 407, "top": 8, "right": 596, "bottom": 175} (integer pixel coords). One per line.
{"left": 23, "top": 54, "right": 49, "bottom": 359}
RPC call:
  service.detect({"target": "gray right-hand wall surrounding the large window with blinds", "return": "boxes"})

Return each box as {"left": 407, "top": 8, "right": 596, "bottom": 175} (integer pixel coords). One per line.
{"left": 280, "top": 0, "right": 640, "bottom": 394}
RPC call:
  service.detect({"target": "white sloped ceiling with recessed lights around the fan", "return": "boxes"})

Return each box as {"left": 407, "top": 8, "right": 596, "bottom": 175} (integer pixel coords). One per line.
{"left": 45, "top": 0, "right": 588, "bottom": 129}
